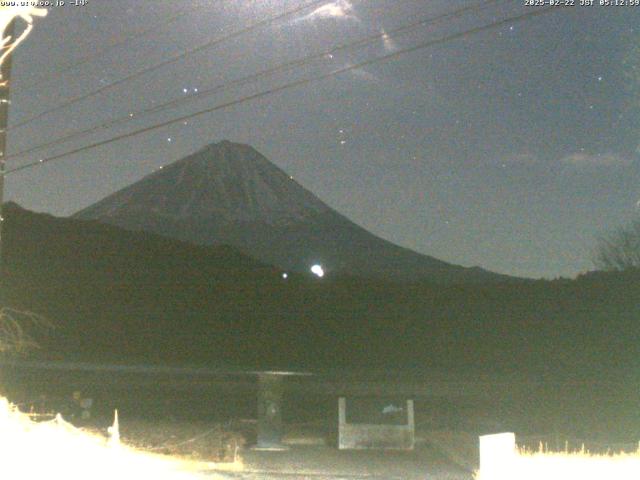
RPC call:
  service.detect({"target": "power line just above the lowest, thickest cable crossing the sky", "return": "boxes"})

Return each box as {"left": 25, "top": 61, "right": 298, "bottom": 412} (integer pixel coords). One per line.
{"left": 6, "top": 0, "right": 507, "bottom": 160}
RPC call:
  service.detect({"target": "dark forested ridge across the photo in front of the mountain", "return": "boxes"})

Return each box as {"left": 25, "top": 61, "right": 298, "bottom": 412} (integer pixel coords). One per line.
{"left": 3, "top": 204, "right": 640, "bottom": 372}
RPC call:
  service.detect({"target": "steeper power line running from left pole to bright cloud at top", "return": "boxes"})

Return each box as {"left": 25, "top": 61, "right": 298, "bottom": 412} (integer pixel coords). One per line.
{"left": 7, "top": 0, "right": 326, "bottom": 131}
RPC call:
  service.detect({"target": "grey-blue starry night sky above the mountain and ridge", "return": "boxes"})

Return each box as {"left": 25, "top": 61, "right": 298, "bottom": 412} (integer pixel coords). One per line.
{"left": 6, "top": 0, "right": 640, "bottom": 278}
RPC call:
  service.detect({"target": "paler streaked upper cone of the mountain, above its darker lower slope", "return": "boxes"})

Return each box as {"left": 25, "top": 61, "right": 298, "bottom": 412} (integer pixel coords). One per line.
{"left": 77, "top": 140, "right": 330, "bottom": 226}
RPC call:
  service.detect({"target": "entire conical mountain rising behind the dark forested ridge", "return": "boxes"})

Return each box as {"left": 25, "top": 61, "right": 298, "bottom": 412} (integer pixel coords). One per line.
{"left": 74, "top": 141, "right": 507, "bottom": 283}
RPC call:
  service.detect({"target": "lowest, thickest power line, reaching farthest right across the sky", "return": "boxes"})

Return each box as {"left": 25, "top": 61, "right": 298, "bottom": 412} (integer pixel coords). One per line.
{"left": 7, "top": 6, "right": 563, "bottom": 174}
